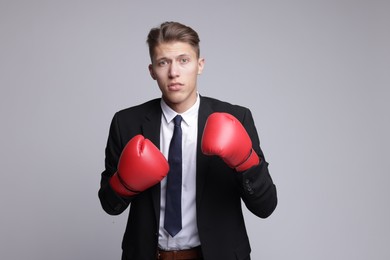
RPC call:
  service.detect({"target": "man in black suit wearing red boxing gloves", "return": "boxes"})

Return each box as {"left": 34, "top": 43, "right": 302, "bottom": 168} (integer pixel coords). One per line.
{"left": 99, "top": 22, "right": 277, "bottom": 260}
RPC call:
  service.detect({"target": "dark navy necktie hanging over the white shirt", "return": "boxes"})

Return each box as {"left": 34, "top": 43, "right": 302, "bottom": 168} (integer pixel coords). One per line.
{"left": 164, "top": 115, "right": 182, "bottom": 237}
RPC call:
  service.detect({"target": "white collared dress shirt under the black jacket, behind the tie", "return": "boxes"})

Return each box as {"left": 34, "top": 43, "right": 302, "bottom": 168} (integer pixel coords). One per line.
{"left": 158, "top": 94, "right": 200, "bottom": 250}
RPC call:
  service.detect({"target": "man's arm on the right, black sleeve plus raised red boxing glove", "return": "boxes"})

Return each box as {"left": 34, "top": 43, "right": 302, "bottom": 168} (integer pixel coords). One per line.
{"left": 202, "top": 109, "right": 277, "bottom": 218}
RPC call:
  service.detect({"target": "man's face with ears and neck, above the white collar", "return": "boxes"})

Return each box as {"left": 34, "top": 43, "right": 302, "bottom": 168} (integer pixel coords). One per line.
{"left": 149, "top": 42, "right": 204, "bottom": 113}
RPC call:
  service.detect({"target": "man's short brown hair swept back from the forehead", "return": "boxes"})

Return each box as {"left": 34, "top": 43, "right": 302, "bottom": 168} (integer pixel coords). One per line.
{"left": 146, "top": 22, "right": 200, "bottom": 59}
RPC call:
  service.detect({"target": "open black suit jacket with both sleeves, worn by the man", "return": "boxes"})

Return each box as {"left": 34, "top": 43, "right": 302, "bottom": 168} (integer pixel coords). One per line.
{"left": 99, "top": 97, "right": 277, "bottom": 260}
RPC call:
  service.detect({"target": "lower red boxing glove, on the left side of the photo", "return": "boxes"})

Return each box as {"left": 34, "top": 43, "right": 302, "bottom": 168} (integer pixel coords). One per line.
{"left": 110, "top": 135, "right": 169, "bottom": 197}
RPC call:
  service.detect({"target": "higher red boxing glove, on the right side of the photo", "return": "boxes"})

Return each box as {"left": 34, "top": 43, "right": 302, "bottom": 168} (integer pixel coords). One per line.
{"left": 202, "top": 113, "right": 260, "bottom": 172}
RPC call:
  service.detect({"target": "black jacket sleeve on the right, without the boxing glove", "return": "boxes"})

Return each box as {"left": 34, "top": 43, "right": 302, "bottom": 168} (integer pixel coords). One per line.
{"left": 237, "top": 109, "right": 277, "bottom": 218}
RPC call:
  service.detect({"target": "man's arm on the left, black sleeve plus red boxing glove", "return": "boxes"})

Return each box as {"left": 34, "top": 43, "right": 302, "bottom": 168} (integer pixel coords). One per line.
{"left": 99, "top": 112, "right": 169, "bottom": 215}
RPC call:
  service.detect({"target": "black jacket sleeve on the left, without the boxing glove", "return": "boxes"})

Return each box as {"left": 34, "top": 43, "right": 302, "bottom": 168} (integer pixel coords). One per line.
{"left": 98, "top": 114, "right": 131, "bottom": 215}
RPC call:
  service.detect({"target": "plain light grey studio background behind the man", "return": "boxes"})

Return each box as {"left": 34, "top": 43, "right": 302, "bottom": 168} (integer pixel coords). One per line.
{"left": 0, "top": 0, "right": 390, "bottom": 260}
